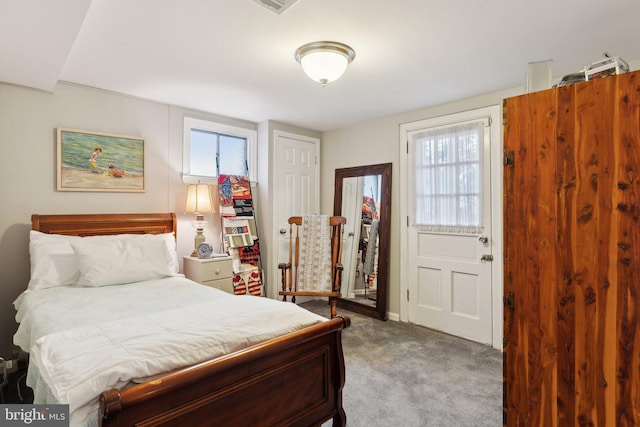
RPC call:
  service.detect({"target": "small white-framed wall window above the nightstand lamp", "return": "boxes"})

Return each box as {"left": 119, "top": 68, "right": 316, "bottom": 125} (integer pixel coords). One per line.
{"left": 182, "top": 117, "right": 257, "bottom": 184}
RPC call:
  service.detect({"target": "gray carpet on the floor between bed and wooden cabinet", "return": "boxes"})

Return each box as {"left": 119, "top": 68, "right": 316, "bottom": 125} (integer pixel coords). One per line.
{"left": 302, "top": 301, "right": 502, "bottom": 427}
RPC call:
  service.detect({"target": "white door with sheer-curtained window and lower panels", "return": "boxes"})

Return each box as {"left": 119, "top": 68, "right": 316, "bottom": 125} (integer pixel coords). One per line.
{"left": 406, "top": 108, "right": 498, "bottom": 344}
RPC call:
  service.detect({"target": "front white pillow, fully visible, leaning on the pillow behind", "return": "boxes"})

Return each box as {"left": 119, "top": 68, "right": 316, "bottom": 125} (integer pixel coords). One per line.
{"left": 69, "top": 235, "right": 174, "bottom": 287}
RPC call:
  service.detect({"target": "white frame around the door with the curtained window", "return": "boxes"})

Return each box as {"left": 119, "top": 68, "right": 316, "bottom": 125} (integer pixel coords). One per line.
{"left": 399, "top": 105, "right": 504, "bottom": 350}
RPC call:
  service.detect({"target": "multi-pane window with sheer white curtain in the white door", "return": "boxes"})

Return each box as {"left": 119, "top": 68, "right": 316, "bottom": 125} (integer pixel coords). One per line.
{"left": 412, "top": 121, "right": 485, "bottom": 233}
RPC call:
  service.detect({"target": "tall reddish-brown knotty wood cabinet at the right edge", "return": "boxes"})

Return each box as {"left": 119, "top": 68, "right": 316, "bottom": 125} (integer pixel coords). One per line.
{"left": 503, "top": 69, "right": 640, "bottom": 427}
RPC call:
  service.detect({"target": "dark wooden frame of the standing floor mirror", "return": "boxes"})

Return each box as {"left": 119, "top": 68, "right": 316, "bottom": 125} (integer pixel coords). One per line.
{"left": 333, "top": 163, "right": 391, "bottom": 320}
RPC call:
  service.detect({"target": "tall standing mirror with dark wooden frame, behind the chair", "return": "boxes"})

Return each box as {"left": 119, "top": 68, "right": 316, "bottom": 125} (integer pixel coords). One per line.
{"left": 333, "top": 163, "right": 391, "bottom": 320}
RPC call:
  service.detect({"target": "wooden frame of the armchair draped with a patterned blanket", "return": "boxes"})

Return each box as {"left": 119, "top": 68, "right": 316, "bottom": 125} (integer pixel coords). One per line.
{"left": 278, "top": 216, "right": 347, "bottom": 319}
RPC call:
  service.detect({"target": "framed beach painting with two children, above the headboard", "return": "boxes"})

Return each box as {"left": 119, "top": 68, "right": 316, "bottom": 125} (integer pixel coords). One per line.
{"left": 58, "top": 129, "right": 144, "bottom": 192}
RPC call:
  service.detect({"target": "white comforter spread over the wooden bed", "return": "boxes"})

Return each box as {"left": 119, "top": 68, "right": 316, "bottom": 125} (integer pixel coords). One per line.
{"left": 14, "top": 277, "right": 326, "bottom": 422}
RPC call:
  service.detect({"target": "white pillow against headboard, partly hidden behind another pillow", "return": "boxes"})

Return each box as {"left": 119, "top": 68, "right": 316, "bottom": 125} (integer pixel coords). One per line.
{"left": 27, "top": 234, "right": 179, "bottom": 290}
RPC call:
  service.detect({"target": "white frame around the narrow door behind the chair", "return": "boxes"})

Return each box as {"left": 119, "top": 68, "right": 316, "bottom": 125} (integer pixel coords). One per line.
{"left": 267, "top": 130, "right": 320, "bottom": 299}
